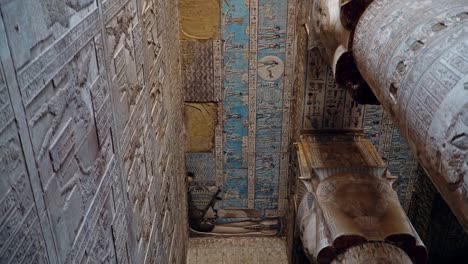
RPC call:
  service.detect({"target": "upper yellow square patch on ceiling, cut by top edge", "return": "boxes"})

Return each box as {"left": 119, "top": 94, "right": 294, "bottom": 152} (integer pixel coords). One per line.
{"left": 179, "top": 0, "right": 221, "bottom": 39}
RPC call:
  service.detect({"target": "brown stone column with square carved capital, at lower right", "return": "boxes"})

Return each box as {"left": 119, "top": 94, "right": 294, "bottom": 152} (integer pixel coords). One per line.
{"left": 295, "top": 134, "right": 427, "bottom": 264}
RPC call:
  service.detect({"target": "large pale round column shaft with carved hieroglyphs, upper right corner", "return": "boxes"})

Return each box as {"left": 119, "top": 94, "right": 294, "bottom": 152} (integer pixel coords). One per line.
{"left": 352, "top": 0, "right": 468, "bottom": 229}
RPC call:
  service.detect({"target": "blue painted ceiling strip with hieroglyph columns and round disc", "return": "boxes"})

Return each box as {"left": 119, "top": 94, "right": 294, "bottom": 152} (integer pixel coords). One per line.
{"left": 210, "top": 0, "right": 295, "bottom": 215}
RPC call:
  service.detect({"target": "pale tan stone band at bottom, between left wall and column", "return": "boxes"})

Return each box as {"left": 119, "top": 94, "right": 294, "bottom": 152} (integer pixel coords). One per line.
{"left": 187, "top": 237, "right": 288, "bottom": 264}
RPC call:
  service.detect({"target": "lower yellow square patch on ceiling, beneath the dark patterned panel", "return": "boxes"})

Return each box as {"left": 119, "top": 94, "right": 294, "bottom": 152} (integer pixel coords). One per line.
{"left": 185, "top": 103, "right": 217, "bottom": 152}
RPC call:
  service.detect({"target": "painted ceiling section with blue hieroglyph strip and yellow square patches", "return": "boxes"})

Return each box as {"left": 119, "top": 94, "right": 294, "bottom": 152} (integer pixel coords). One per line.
{"left": 180, "top": 0, "right": 296, "bottom": 218}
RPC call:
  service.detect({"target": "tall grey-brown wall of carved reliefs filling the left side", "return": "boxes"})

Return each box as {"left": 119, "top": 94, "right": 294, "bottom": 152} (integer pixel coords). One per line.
{"left": 0, "top": 0, "right": 187, "bottom": 263}
